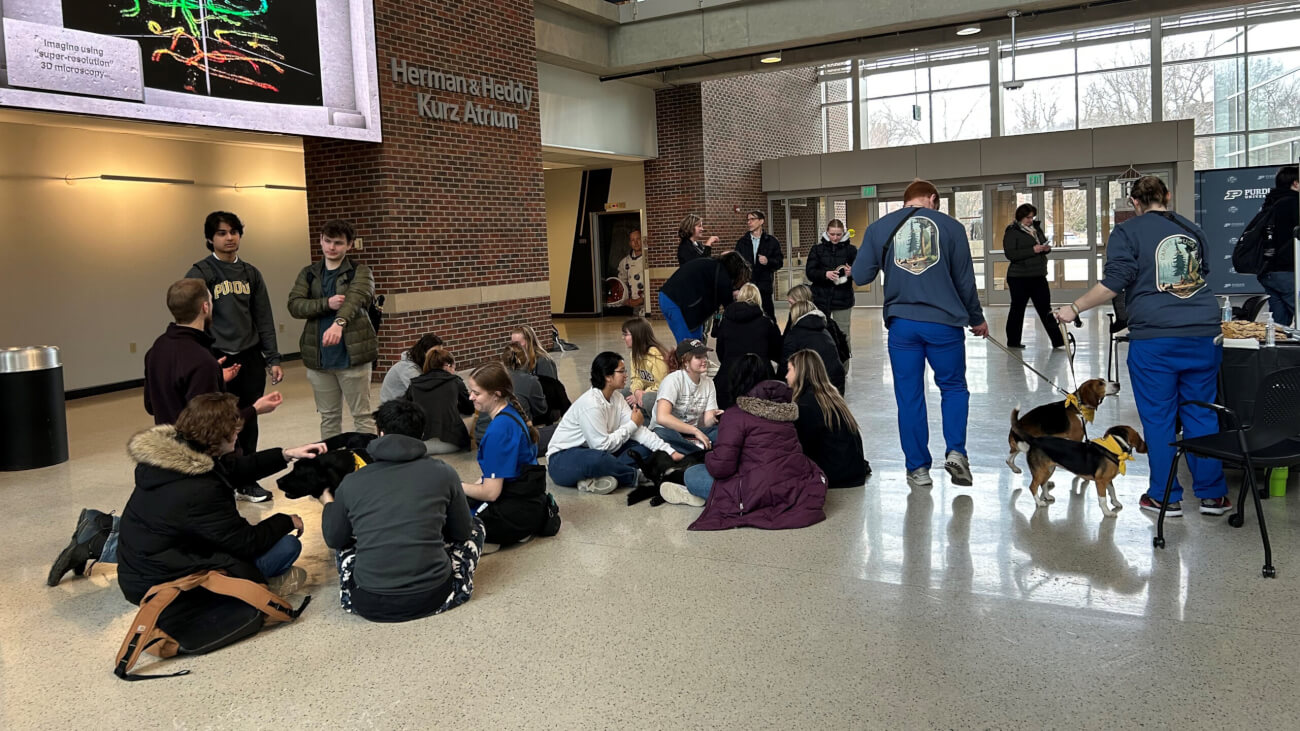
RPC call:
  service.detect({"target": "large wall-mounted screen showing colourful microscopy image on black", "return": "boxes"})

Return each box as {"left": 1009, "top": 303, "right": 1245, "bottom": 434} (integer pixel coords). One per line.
{"left": 0, "top": 0, "right": 381, "bottom": 142}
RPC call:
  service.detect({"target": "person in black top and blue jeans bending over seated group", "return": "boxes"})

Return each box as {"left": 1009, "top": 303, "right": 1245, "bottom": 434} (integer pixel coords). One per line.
{"left": 659, "top": 251, "right": 750, "bottom": 342}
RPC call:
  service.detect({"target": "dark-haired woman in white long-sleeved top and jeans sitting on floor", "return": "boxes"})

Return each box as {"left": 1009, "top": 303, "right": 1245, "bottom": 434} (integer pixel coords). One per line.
{"left": 546, "top": 351, "right": 683, "bottom": 494}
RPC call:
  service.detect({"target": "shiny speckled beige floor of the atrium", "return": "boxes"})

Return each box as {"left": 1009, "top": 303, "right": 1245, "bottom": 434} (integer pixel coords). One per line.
{"left": 0, "top": 308, "right": 1300, "bottom": 730}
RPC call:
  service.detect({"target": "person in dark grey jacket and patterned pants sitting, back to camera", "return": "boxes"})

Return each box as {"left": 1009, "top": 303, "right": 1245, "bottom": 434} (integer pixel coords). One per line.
{"left": 320, "top": 401, "right": 484, "bottom": 622}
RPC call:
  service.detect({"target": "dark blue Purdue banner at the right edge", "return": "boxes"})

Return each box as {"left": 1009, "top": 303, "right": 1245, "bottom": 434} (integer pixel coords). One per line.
{"left": 1196, "top": 165, "right": 1278, "bottom": 294}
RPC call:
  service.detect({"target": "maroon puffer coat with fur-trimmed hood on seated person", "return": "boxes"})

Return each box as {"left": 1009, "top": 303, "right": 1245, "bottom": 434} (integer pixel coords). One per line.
{"left": 690, "top": 381, "right": 826, "bottom": 531}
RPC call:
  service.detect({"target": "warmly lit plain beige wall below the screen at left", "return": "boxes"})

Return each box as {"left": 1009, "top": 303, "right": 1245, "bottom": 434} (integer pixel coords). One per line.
{"left": 0, "top": 114, "right": 311, "bottom": 389}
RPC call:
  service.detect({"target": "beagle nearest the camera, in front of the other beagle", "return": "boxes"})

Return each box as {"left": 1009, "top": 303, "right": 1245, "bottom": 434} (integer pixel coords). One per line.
{"left": 1019, "top": 425, "right": 1147, "bottom": 518}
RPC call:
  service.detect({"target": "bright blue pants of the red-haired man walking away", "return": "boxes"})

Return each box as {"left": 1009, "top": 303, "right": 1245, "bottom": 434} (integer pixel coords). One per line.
{"left": 889, "top": 317, "right": 971, "bottom": 472}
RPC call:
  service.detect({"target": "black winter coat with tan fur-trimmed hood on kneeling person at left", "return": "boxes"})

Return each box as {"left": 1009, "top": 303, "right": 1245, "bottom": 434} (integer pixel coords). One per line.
{"left": 117, "top": 425, "right": 294, "bottom": 604}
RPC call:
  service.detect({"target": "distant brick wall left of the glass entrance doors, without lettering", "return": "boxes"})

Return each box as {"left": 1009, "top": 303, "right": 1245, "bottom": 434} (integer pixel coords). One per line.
{"left": 645, "top": 69, "right": 822, "bottom": 308}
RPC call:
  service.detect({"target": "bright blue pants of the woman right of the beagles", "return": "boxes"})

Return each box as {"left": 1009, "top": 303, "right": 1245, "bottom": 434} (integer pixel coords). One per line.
{"left": 1128, "top": 337, "right": 1227, "bottom": 502}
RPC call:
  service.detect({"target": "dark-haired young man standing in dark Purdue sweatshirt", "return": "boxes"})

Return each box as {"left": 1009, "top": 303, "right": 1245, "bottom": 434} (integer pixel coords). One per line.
{"left": 186, "top": 211, "right": 285, "bottom": 502}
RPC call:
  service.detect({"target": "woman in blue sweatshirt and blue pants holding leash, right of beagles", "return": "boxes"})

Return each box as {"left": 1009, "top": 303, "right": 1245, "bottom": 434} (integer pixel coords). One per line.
{"left": 1056, "top": 176, "right": 1232, "bottom": 518}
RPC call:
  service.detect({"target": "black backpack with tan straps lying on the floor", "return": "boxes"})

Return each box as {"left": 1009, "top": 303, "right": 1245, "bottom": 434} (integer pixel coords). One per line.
{"left": 113, "top": 571, "right": 312, "bottom": 680}
